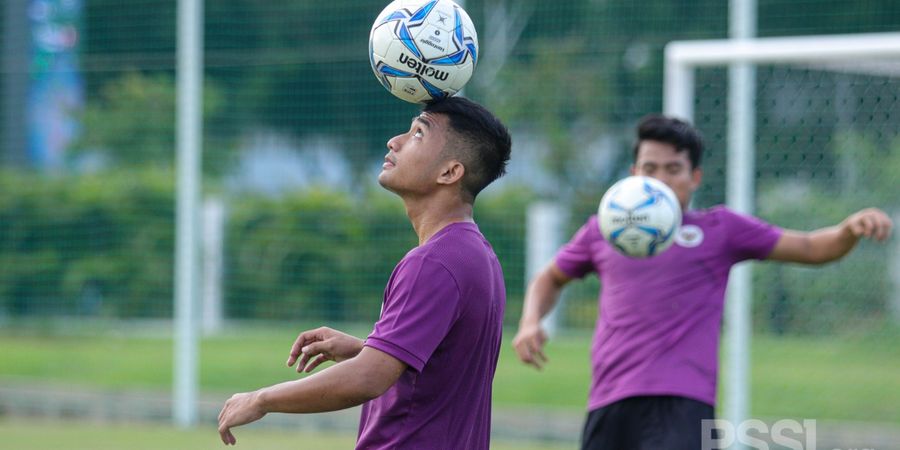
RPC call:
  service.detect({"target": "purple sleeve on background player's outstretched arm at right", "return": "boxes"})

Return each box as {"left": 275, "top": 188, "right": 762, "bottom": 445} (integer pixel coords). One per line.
{"left": 725, "top": 209, "right": 783, "bottom": 262}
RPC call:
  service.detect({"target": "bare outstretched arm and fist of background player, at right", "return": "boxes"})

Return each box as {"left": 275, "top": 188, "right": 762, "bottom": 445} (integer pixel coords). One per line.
{"left": 767, "top": 208, "right": 893, "bottom": 264}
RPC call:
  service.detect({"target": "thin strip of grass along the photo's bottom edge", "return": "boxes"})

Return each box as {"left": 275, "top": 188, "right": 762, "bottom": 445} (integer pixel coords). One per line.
{"left": 0, "top": 419, "right": 571, "bottom": 450}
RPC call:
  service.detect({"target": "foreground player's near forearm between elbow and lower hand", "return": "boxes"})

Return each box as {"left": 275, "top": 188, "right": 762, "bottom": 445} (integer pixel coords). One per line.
{"left": 258, "top": 360, "right": 382, "bottom": 413}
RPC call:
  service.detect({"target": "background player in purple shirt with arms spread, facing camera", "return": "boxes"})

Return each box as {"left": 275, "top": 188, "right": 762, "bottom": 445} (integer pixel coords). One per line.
{"left": 513, "top": 115, "right": 892, "bottom": 450}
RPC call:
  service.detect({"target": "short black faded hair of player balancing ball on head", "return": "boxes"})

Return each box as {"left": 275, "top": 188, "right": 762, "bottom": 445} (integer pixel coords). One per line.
{"left": 422, "top": 96, "right": 512, "bottom": 202}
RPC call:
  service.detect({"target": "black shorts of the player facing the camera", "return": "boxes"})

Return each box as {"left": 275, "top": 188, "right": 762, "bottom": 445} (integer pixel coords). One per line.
{"left": 581, "top": 396, "right": 715, "bottom": 450}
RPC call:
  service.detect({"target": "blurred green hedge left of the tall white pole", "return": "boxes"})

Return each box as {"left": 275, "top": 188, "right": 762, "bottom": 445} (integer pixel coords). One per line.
{"left": 0, "top": 171, "right": 174, "bottom": 317}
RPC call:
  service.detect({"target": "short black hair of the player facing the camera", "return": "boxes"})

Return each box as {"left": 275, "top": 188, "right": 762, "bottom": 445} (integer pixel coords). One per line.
{"left": 634, "top": 114, "right": 703, "bottom": 169}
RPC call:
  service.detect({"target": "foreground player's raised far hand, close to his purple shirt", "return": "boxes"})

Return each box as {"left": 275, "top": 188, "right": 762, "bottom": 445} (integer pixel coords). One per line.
{"left": 287, "top": 327, "right": 363, "bottom": 372}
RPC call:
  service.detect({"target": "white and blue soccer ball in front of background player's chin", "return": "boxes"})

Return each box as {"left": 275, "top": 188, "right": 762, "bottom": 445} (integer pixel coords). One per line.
{"left": 597, "top": 176, "right": 681, "bottom": 258}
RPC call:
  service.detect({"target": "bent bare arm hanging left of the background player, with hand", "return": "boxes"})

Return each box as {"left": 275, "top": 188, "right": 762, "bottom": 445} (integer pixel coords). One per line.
{"left": 513, "top": 262, "right": 572, "bottom": 369}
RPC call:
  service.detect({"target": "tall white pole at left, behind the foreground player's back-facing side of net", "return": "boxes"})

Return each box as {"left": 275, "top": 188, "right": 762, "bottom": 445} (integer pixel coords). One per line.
{"left": 172, "top": 0, "right": 203, "bottom": 427}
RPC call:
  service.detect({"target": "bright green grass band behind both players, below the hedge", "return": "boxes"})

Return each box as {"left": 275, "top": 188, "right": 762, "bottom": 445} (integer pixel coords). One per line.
{"left": 0, "top": 327, "right": 900, "bottom": 423}
